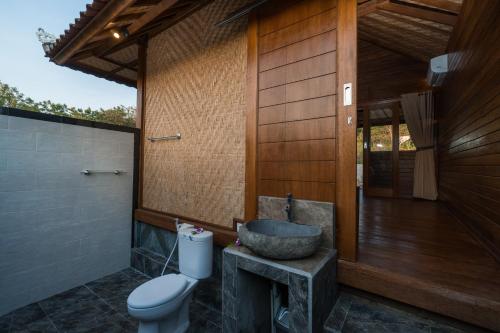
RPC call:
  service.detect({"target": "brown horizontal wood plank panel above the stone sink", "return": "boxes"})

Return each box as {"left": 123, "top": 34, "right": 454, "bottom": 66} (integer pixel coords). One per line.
{"left": 257, "top": 0, "right": 337, "bottom": 202}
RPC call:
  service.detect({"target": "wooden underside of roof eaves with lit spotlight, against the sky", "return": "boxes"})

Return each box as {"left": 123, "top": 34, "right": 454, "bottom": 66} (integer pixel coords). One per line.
{"left": 46, "top": 0, "right": 210, "bottom": 87}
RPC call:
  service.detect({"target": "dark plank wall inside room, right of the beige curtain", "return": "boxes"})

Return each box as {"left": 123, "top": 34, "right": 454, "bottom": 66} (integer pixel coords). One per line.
{"left": 437, "top": 0, "right": 500, "bottom": 261}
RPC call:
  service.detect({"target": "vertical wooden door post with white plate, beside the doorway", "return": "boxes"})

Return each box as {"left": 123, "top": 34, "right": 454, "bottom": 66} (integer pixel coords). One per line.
{"left": 336, "top": 0, "right": 358, "bottom": 261}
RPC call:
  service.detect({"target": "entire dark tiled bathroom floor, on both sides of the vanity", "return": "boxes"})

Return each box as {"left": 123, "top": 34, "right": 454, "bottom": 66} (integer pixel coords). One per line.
{"left": 0, "top": 268, "right": 484, "bottom": 333}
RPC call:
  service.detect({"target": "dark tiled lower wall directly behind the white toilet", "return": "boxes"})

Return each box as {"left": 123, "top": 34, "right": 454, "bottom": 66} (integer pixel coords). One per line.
{"left": 131, "top": 222, "right": 223, "bottom": 312}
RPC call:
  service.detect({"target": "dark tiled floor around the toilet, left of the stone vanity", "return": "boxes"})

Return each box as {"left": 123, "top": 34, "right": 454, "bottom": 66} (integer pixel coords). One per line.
{"left": 0, "top": 269, "right": 221, "bottom": 333}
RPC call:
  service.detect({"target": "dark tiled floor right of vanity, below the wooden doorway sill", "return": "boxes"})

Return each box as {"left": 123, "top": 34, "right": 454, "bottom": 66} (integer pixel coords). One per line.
{"left": 324, "top": 288, "right": 492, "bottom": 333}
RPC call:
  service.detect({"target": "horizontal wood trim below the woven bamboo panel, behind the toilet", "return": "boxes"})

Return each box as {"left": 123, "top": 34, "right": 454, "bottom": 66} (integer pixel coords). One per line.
{"left": 134, "top": 208, "right": 238, "bottom": 246}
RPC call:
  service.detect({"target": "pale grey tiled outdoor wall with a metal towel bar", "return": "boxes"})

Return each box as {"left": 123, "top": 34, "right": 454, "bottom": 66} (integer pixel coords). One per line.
{"left": 0, "top": 115, "right": 134, "bottom": 315}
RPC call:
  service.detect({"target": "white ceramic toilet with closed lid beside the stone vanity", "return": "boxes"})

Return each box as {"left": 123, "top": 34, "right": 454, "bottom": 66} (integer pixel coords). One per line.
{"left": 127, "top": 227, "right": 213, "bottom": 333}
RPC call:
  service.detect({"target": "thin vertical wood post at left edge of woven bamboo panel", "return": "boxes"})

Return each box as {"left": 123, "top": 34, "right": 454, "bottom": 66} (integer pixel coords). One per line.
{"left": 135, "top": 37, "right": 148, "bottom": 208}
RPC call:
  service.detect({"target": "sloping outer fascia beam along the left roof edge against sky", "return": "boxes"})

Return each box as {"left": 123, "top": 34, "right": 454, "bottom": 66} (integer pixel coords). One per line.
{"left": 52, "top": 0, "right": 135, "bottom": 65}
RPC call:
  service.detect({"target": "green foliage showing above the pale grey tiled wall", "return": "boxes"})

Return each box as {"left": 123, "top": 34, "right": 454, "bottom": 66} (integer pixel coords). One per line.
{"left": 0, "top": 81, "right": 135, "bottom": 127}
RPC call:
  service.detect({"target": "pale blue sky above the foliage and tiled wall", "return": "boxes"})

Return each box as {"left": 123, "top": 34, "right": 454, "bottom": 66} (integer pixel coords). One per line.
{"left": 0, "top": 0, "right": 136, "bottom": 109}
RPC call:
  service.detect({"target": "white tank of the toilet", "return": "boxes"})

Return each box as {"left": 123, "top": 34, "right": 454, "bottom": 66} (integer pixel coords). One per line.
{"left": 179, "top": 227, "right": 213, "bottom": 279}
